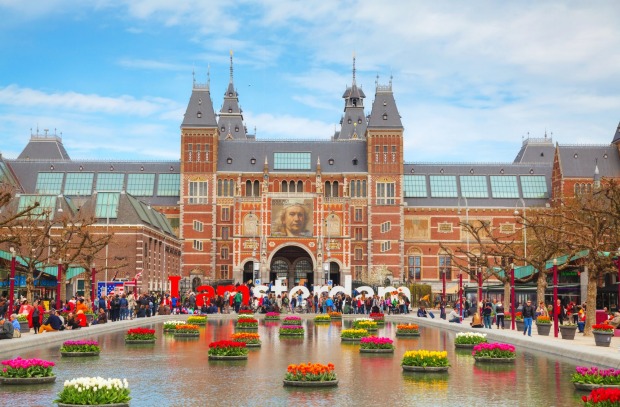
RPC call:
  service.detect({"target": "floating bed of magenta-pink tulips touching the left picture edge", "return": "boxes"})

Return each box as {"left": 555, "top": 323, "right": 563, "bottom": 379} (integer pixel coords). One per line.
{"left": 0, "top": 357, "right": 56, "bottom": 384}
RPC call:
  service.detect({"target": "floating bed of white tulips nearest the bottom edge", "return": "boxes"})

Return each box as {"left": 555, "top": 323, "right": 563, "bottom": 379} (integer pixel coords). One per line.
{"left": 54, "top": 377, "right": 131, "bottom": 406}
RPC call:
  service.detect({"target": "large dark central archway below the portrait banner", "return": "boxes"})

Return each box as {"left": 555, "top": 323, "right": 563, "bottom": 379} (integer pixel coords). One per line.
{"left": 267, "top": 246, "right": 314, "bottom": 289}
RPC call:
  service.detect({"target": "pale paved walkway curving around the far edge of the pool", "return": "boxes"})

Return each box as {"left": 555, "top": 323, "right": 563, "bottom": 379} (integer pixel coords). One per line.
{"left": 0, "top": 311, "right": 620, "bottom": 369}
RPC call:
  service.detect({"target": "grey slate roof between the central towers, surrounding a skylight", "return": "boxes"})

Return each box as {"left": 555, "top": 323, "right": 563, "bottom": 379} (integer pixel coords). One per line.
{"left": 217, "top": 140, "right": 368, "bottom": 173}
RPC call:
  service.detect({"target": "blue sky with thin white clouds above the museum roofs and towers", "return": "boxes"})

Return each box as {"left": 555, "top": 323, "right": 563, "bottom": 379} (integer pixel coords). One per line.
{"left": 0, "top": 0, "right": 620, "bottom": 162}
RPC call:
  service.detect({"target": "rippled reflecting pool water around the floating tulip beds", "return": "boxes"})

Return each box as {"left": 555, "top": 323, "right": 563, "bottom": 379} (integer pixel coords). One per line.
{"left": 0, "top": 319, "right": 587, "bottom": 407}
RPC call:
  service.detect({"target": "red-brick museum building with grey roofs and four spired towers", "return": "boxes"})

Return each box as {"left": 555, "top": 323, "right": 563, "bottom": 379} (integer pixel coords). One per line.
{"left": 0, "top": 57, "right": 620, "bottom": 310}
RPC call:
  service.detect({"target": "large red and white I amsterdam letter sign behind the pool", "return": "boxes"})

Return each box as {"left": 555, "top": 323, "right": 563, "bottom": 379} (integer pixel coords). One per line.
{"left": 168, "top": 276, "right": 411, "bottom": 306}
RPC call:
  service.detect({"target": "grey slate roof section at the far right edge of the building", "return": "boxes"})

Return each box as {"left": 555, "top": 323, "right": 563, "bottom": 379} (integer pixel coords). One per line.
{"left": 558, "top": 144, "right": 620, "bottom": 179}
